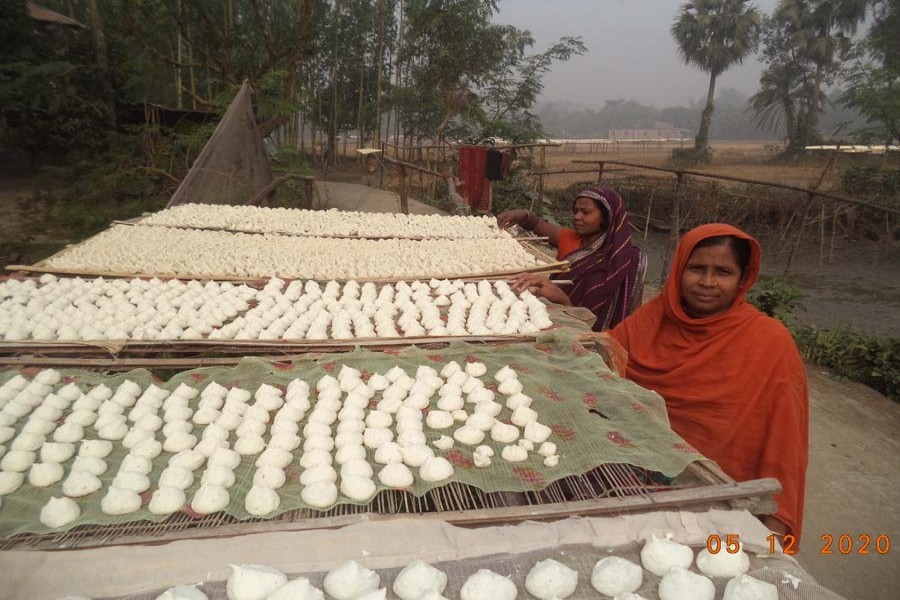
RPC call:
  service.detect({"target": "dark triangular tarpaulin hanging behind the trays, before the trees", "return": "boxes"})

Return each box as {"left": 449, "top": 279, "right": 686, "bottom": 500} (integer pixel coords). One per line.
{"left": 166, "top": 81, "right": 272, "bottom": 208}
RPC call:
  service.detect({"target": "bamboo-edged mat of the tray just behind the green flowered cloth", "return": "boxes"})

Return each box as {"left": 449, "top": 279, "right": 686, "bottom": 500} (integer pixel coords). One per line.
{"left": 0, "top": 303, "right": 597, "bottom": 357}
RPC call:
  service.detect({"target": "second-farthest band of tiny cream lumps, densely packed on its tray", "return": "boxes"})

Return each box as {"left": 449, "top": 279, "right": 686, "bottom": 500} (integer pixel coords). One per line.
{"left": 46, "top": 225, "right": 538, "bottom": 281}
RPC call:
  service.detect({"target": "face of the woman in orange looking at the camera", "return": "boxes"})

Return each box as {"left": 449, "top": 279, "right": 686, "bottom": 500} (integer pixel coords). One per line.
{"left": 681, "top": 244, "right": 744, "bottom": 319}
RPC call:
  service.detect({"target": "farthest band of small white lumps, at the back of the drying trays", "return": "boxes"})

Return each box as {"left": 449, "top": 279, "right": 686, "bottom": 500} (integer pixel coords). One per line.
{"left": 141, "top": 204, "right": 509, "bottom": 239}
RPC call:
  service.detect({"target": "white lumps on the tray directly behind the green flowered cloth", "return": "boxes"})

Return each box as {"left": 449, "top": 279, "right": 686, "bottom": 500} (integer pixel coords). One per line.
{"left": 0, "top": 275, "right": 552, "bottom": 341}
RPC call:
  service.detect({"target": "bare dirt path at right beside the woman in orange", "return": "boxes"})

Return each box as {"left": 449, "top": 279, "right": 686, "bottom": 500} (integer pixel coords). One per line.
{"left": 797, "top": 365, "right": 900, "bottom": 600}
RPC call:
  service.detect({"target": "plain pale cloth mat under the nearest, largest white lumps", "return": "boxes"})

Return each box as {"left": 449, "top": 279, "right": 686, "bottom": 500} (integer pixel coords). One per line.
{"left": 0, "top": 510, "right": 841, "bottom": 600}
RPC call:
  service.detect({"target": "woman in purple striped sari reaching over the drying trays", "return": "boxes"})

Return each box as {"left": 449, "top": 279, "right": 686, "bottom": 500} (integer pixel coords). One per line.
{"left": 497, "top": 187, "right": 646, "bottom": 331}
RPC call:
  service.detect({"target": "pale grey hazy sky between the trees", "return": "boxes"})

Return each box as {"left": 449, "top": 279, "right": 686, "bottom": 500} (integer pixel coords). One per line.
{"left": 495, "top": 0, "right": 778, "bottom": 107}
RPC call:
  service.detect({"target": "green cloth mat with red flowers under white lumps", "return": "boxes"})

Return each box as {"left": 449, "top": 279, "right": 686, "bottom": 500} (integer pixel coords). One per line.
{"left": 0, "top": 332, "right": 702, "bottom": 537}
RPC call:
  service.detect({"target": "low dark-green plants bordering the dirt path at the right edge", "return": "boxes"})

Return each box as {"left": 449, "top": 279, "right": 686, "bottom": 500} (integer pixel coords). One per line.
{"left": 793, "top": 327, "right": 900, "bottom": 401}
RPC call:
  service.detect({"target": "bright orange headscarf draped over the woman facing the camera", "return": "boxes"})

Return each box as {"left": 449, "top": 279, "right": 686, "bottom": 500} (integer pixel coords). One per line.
{"left": 612, "top": 223, "right": 809, "bottom": 537}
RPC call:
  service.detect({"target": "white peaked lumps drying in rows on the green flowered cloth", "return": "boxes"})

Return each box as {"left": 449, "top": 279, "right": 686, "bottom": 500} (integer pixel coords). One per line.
{"left": 0, "top": 362, "right": 559, "bottom": 527}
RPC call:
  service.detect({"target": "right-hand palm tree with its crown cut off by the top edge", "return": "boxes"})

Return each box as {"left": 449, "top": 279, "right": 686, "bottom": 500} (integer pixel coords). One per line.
{"left": 775, "top": 0, "right": 869, "bottom": 147}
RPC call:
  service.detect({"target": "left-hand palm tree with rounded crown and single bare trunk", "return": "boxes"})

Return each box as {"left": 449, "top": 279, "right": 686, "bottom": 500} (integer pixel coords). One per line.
{"left": 671, "top": 0, "right": 761, "bottom": 157}
